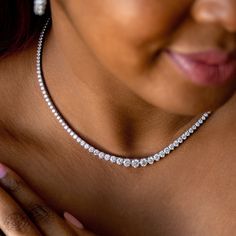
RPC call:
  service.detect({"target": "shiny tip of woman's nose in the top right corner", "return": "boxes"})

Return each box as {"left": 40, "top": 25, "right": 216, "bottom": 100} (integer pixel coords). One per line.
{"left": 192, "top": 0, "right": 236, "bottom": 32}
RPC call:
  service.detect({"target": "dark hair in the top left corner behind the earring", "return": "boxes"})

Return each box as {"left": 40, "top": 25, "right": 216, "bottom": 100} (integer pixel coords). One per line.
{"left": 0, "top": 0, "right": 51, "bottom": 58}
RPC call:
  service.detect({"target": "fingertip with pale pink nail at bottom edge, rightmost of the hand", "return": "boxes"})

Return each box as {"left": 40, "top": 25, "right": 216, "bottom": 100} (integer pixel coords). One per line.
{"left": 63, "top": 212, "right": 95, "bottom": 236}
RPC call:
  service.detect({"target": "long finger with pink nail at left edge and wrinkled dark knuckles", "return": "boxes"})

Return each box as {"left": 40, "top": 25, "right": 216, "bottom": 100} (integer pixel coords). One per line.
{"left": 0, "top": 164, "right": 73, "bottom": 236}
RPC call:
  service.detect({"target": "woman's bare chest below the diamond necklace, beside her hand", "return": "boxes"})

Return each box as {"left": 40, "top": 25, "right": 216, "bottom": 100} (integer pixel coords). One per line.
{"left": 0, "top": 129, "right": 236, "bottom": 236}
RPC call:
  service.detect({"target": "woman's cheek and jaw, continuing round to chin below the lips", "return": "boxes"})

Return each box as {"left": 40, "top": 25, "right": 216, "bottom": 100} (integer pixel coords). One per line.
{"left": 61, "top": 0, "right": 236, "bottom": 114}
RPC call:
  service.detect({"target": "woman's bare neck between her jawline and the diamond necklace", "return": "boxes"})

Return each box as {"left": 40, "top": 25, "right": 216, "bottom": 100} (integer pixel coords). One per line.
{"left": 42, "top": 13, "right": 195, "bottom": 157}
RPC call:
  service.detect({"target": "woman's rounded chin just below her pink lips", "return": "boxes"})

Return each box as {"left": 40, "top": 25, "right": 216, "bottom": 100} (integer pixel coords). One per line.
{"left": 138, "top": 54, "right": 236, "bottom": 116}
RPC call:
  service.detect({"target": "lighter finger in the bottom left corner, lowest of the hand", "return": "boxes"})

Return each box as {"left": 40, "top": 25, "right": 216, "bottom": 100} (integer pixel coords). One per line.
{"left": 0, "top": 185, "right": 41, "bottom": 236}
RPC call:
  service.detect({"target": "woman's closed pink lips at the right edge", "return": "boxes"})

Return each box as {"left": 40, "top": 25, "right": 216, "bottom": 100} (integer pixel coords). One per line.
{"left": 167, "top": 50, "right": 236, "bottom": 86}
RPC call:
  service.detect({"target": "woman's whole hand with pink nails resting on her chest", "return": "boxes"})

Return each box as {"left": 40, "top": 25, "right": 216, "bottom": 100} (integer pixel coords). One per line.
{"left": 0, "top": 163, "right": 95, "bottom": 236}
